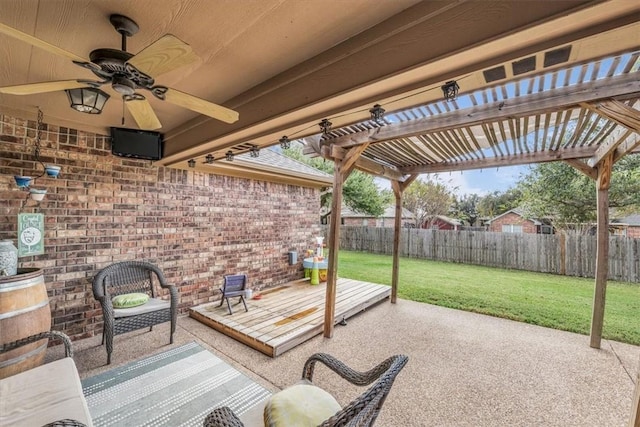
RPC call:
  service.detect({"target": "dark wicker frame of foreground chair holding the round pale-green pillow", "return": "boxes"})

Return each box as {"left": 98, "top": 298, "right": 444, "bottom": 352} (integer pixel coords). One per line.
{"left": 203, "top": 353, "right": 409, "bottom": 427}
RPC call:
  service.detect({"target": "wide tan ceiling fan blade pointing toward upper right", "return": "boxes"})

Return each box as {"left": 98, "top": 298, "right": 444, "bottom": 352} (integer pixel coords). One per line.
{"left": 127, "top": 34, "right": 198, "bottom": 77}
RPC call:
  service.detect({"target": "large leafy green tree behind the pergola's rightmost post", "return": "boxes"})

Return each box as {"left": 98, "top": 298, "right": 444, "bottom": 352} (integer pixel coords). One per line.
{"left": 517, "top": 155, "right": 640, "bottom": 230}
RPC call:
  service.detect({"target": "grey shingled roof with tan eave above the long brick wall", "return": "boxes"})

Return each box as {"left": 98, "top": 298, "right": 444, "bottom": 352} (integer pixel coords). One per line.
{"left": 208, "top": 149, "right": 333, "bottom": 187}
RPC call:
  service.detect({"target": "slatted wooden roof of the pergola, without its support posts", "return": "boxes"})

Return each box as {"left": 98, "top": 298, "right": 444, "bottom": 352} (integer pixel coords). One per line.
{"left": 305, "top": 51, "right": 640, "bottom": 182}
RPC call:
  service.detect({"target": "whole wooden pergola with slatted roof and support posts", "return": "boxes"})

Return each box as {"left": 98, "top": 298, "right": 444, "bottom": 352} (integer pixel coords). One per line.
{"left": 306, "top": 28, "right": 640, "bottom": 426}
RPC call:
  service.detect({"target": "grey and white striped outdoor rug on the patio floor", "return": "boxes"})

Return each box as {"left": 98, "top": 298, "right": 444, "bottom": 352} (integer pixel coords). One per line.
{"left": 82, "top": 342, "right": 270, "bottom": 427}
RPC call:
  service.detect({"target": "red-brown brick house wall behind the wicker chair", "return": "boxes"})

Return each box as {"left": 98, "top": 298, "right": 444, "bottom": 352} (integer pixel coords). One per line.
{"left": 0, "top": 115, "right": 320, "bottom": 339}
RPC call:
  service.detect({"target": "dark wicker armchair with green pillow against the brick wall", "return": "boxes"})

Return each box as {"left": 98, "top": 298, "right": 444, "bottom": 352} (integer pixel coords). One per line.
{"left": 93, "top": 261, "right": 178, "bottom": 364}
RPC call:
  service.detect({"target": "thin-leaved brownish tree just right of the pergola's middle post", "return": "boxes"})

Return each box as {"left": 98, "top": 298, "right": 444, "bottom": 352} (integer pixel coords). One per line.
{"left": 402, "top": 177, "right": 453, "bottom": 228}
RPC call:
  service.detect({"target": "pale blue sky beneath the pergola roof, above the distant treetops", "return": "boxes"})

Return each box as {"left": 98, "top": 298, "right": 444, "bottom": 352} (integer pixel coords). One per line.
{"left": 376, "top": 166, "right": 529, "bottom": 196}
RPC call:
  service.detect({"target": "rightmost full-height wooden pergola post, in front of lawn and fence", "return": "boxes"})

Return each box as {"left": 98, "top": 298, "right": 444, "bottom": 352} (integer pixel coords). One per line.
{"left": 590, "top": 154, "right": 613, "bottom": 348}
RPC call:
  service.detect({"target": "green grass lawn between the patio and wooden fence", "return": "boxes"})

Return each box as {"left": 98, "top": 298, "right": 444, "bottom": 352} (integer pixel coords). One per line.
{"left": 338, "top": 251, "right": 640, "bottom": 345}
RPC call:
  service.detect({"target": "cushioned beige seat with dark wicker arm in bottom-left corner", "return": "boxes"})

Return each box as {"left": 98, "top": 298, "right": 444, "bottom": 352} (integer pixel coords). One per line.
{"left": 0, "top": 331, "right": 93, "bottom": 427}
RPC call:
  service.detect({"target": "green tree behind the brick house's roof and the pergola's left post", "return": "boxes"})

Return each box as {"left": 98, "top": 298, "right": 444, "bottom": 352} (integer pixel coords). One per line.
{"left": 282, "top": 147, "right": 393, "bottom": 221}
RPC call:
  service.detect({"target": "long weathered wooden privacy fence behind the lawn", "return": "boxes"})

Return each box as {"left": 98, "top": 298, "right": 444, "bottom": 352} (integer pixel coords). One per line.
{"left": 340, "top": 226, "right": 640, "bottom": 283}
